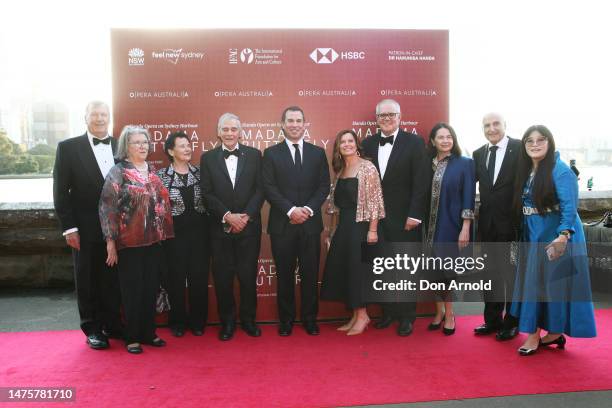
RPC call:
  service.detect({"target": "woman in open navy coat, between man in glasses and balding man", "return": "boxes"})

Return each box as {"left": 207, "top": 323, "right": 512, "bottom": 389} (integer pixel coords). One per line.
{"left": 425, "top": 123, "right": 476, "bottom": 335}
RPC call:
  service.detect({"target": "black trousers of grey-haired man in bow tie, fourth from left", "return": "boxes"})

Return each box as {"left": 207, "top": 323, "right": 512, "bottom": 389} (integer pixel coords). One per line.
{"left": 212, "top": 234, "right": 261, "bottom": 323}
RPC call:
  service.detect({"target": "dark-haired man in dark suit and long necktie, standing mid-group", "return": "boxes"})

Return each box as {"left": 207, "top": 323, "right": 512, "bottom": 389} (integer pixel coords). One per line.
{"left": 263, "top": 106, "right": 330, "bottom": 336}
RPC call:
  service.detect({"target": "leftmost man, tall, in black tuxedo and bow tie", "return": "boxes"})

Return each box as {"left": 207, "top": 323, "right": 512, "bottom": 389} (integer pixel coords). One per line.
{"left": 53, "top": 101, "right": 122, "bottom": 349}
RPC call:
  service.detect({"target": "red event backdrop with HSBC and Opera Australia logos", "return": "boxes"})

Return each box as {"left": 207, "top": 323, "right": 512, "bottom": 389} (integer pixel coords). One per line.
{"left": 111, "top": 29, "right": 448, "bottom": 321}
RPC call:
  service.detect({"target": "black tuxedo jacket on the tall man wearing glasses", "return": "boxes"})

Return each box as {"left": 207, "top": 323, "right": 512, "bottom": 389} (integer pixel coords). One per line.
{"left": 362, "top": 129, "right": 429, "bottom": 240}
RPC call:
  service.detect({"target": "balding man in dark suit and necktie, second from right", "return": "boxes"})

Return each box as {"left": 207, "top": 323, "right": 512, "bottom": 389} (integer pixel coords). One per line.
{"left": 474, "top": 113, "right": 521, "bottom": 340}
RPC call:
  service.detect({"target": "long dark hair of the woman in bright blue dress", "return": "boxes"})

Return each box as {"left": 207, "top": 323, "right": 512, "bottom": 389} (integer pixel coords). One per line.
{"left": 514, "top": 125, "right": 558, "bottom": 219}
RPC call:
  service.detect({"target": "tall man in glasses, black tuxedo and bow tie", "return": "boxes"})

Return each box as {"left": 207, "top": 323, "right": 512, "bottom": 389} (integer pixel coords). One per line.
{"left": 363, "top": 99, "right": 427, "bottom": 336}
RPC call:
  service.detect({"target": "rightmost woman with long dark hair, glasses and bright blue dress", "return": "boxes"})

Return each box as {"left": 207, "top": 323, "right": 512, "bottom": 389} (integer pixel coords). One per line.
{"left": 511, "top": 125, "right": 596, "bottom": 356}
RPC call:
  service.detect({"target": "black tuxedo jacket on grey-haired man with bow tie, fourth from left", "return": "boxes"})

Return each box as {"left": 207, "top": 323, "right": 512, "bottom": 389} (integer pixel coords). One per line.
{"left": 200, "top": 144, "right": 264, "bottom": 238}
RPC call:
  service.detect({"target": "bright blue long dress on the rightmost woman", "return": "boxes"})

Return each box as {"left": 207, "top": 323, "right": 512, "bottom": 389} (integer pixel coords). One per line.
{"left": 511, "top": 153, "right": 596, "bottom": 337}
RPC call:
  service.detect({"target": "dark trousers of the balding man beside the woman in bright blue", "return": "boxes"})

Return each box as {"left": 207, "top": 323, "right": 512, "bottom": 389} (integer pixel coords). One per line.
{"left": 481, "top": 231, "right": 518, "bottom": 329}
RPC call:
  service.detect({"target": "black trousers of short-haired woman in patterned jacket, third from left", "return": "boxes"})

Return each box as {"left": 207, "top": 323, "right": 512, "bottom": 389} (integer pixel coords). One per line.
{"left": 163, "top": 218, "right": 211, "bottom": 330}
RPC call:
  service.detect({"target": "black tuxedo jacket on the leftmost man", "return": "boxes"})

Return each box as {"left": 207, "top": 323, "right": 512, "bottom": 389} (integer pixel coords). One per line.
{"left": 53, "top": 133, "right": 117, "bottom": 242}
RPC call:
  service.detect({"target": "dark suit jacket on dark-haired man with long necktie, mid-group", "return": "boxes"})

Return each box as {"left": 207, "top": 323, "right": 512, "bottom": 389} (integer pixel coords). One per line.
{"left": 263, "top": 140, "right": 330, "bottom": 234}
